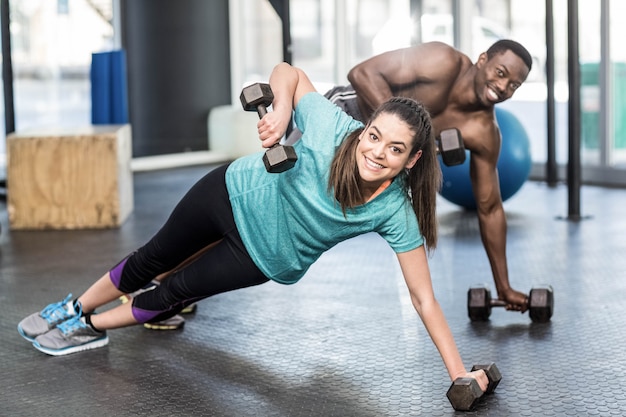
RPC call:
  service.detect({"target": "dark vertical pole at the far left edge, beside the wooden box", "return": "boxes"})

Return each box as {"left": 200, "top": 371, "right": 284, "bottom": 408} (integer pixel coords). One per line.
{"left": 0, "top": 0, "right": 15, "bottom": 135}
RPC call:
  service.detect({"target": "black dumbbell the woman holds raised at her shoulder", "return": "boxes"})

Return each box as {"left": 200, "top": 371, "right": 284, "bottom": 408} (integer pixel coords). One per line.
{"left": 239, "top": 83, "right": 298, "bottom": 173}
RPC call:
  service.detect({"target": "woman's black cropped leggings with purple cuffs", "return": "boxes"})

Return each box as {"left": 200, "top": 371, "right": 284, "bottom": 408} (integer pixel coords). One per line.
{"left": 110, "top": 165, "right": 268, "bottom": 323}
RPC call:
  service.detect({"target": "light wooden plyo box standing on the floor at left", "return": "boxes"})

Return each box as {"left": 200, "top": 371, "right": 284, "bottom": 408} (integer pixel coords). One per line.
{"left": 7, "top": 124, "right": 134, "bottom": 230}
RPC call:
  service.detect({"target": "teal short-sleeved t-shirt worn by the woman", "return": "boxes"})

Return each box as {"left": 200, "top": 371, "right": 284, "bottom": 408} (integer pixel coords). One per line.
{"left": 226, "top": 93, "right": 423, "bottom": 284}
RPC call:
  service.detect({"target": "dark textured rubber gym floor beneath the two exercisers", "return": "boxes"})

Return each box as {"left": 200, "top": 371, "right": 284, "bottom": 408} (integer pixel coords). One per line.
{"left": 0, "top": 162, "right": 626, "bottom": 417}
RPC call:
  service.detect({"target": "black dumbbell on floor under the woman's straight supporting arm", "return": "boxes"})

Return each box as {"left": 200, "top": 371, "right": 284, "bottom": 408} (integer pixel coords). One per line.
{"left": 446, "top": 363, "right": 502, "bottom": 411}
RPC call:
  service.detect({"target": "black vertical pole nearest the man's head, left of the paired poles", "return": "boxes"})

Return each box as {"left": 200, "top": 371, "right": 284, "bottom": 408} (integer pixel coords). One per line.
{"left": 546, "top": 0, "right": 559, "bottom": 187}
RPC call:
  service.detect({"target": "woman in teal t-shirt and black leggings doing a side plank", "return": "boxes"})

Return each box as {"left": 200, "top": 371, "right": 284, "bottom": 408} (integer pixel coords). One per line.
{"left": 18, "top": 63, "right": 487, "bottom": 391}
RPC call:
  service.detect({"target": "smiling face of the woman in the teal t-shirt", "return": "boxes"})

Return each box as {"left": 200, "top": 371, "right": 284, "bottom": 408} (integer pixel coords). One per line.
{"left": 356, "top": 113, "right": 422, "bottom": 188}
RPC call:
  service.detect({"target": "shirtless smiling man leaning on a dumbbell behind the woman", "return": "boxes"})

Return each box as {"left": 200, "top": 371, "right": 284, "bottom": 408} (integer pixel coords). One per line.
{"left": 304, "top": 40, "right": 532, "bottom": 312}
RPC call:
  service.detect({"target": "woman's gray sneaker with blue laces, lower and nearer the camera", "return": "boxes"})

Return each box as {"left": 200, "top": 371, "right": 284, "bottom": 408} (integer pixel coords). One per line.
{"left": 33, "top": 316, "right": 109, "bottom": 356}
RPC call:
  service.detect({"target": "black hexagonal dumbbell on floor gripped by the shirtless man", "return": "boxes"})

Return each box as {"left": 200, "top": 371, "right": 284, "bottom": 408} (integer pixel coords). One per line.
{"left": 467, "top": 285, "right": 554, "bottom": 323}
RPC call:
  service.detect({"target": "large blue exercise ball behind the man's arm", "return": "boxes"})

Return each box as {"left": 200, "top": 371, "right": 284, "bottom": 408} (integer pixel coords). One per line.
{"left": 439, "top": 108, "right": 532, "bottom": 210}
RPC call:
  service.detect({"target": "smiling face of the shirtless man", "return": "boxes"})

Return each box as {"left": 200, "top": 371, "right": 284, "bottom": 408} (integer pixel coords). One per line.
{"left": 474, "top": 51, "right": 529, "bottom": 106}
